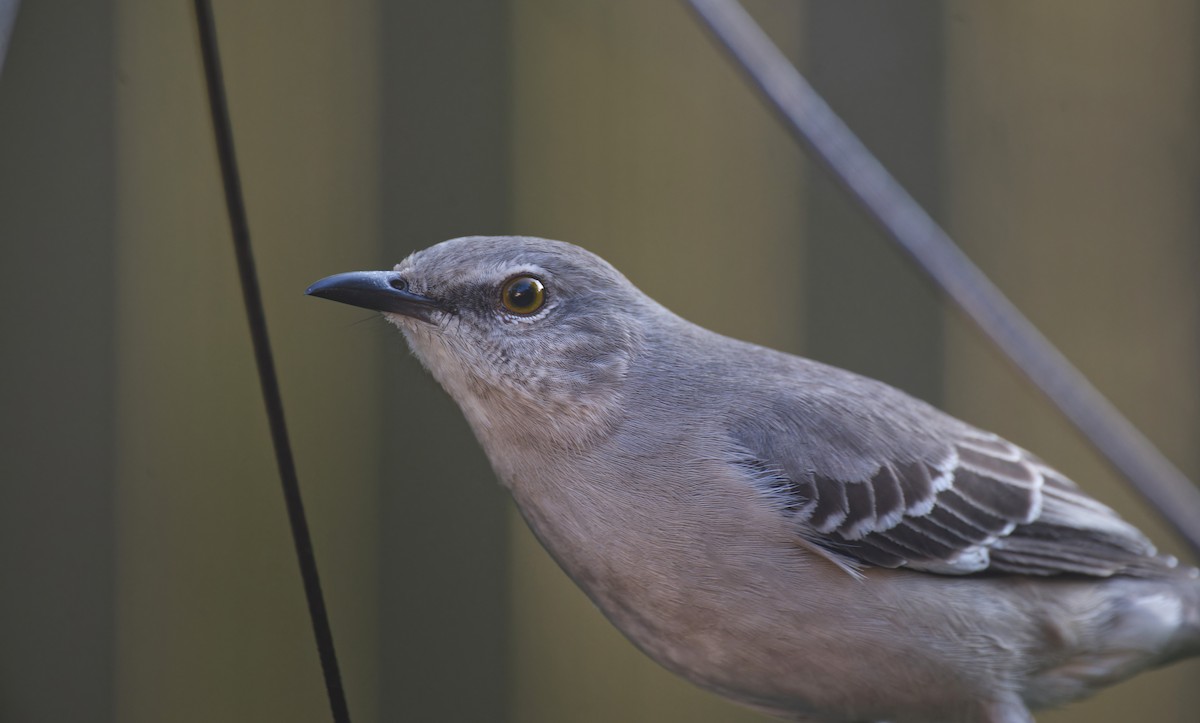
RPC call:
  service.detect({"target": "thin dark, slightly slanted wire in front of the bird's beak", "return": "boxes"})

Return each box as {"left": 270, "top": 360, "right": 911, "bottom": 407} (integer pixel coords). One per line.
{"left": 196, "top": 0, "right": 350, "bottom": 723}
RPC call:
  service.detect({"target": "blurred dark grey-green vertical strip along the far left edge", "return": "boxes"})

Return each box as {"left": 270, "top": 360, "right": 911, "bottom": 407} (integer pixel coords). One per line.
{"left": 0, "top": 0, "right": 116, "bottom": 723}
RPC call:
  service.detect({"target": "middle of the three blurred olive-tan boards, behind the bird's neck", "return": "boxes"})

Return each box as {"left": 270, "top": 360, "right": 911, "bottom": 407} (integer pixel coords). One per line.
{"left": 510, "top": 0, "right": 804, "bottom": 723}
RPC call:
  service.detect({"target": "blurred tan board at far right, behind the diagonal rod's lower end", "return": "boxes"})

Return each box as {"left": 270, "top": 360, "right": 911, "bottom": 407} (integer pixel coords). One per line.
{"left": 944, "top": 1, "right": 1200, "bottom": 723}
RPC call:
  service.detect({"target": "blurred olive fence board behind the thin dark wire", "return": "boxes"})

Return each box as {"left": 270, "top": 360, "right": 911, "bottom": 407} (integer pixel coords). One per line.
{"left": 112, "top": 0, "right": 380, "bottom": 723}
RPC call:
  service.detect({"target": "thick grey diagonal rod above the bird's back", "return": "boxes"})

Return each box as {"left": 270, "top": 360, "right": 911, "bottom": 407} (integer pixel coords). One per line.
{"left": 688, "top": 0, "right": 1200, "bottom": 557}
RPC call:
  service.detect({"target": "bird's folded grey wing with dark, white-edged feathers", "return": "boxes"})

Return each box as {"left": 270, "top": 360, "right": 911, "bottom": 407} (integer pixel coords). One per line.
{"left": 733, "top": 377, "right": 1172, "bottom": 576}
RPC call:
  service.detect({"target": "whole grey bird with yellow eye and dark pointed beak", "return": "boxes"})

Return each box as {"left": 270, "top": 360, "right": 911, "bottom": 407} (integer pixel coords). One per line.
{"left": 310, "top": 237, "right": 1200, "bottom": 723}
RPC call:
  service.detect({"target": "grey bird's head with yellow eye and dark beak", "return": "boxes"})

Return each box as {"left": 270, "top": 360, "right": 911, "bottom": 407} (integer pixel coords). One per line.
{"left": 306, "top": 237, "right": 656, "bottom": 444}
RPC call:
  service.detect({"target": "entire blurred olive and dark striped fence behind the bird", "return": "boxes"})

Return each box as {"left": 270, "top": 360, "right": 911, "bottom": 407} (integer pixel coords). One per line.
{"left": 0, "top": 0, "right": 1200, "bottom": 723}
